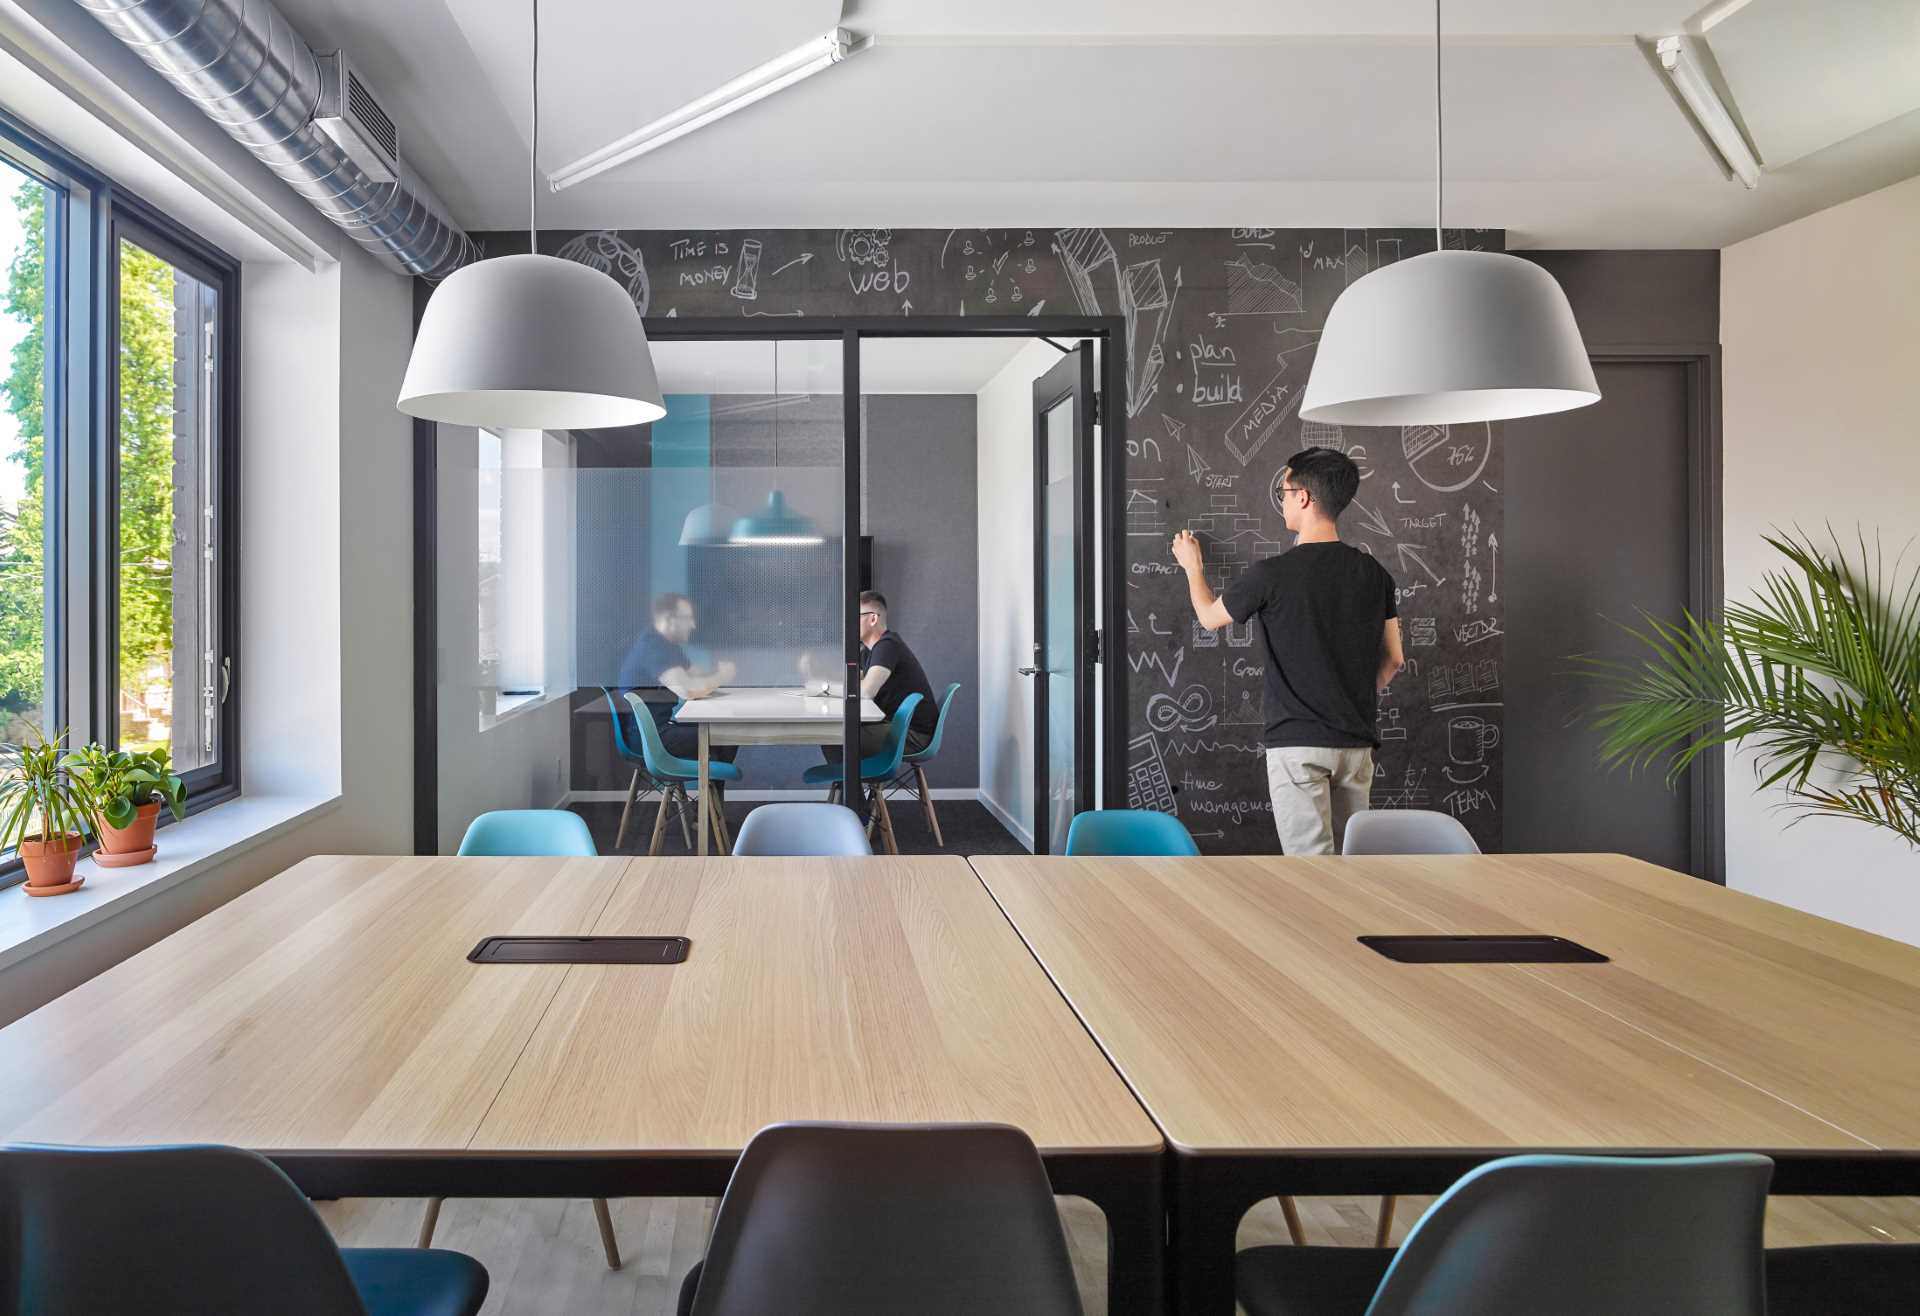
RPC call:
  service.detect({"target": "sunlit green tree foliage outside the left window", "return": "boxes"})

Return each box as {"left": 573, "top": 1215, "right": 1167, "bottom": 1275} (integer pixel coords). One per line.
{"left": 0, "top": 179, "right": 175, "bottom": 747}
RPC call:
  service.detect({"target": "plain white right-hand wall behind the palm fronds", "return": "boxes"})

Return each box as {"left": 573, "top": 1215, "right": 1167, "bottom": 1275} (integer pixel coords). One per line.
{"left": 1720, "top": 179, "right": 1920, "bottom": 945}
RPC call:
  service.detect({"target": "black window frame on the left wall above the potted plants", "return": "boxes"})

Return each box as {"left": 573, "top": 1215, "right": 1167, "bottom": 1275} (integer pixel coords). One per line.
{"left": 0, "top": 110, "right": 244, "bottom": 890}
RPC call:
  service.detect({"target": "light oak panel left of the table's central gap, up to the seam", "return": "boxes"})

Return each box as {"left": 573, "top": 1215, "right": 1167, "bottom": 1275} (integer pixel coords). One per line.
{"left": 472, "top": 857, "right": 1162, "bottom": 1153}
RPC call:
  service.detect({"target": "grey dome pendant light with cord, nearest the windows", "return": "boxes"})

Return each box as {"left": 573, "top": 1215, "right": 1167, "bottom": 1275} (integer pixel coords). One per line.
{"left": 397, "top": 0, "right": 666, "bottom": 430}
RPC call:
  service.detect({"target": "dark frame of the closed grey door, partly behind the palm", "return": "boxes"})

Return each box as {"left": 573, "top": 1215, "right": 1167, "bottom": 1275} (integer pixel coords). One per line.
{"left": 1588, "top": 342, "right": 1726, "bottom": 886}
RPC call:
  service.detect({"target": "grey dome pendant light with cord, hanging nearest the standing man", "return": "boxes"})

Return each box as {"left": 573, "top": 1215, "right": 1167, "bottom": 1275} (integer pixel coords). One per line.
{"left": 1300, "top": 0, "right": 1599, "bottom": 425}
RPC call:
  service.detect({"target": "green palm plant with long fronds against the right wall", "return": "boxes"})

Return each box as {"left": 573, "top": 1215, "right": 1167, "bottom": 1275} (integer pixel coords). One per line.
{"left": 1576, "top": 530, "right": 1920, "bottom": 847}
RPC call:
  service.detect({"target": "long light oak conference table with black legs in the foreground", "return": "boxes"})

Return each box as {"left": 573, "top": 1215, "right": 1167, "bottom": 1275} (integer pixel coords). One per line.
{"left": 0, "top": 855, "right": 1920, "bottom": 1314}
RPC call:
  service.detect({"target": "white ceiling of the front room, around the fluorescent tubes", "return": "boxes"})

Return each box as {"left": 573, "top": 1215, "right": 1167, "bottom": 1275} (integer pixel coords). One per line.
{"left": 278, "top": 0, "right": 1920, "bottom": 248}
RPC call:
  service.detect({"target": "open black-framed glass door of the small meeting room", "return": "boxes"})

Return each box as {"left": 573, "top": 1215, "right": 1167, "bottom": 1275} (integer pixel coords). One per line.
{"left": 1021, "top": 342, "right": 1096, "bottom": 855}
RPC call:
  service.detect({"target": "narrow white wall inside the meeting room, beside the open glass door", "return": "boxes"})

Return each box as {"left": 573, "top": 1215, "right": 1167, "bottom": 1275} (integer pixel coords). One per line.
{"left": 975, "top": 340, "right": 1060, "bottom": 845}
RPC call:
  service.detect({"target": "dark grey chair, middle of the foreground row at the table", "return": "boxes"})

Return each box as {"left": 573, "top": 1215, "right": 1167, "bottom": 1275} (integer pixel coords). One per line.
{"left": 680, "top": 1124, "right": 1081, "bottom": 1316}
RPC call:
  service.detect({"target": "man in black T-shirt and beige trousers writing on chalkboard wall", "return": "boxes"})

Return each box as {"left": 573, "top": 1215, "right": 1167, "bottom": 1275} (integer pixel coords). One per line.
{"left": 1173, "top": 448, "right": 1405, "bottom": 855}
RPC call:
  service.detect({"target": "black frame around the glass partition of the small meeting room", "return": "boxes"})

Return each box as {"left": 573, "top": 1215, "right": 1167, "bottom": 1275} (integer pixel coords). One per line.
{"left": 413, "top": 315, "right": 1127, "bottom": 855}
